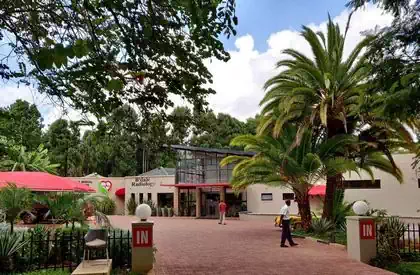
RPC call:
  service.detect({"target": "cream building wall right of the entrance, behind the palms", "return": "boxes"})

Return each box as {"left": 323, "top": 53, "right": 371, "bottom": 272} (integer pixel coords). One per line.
{"left": 247, "top": 154, "right": 420, "bottom": 218}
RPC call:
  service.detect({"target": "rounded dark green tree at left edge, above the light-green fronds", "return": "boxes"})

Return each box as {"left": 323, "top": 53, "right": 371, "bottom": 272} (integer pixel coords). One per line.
{"left": 0, "top": 99, "right": 43, "bottom": 150}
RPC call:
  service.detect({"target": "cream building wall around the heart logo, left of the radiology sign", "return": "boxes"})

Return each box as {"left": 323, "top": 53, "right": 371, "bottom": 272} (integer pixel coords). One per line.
{"left": 71, "top": 177, "right": 125, "bottom": 215}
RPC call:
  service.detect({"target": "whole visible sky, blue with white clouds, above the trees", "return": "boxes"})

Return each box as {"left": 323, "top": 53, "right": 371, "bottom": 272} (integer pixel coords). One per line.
{"left": 0, "top": 0, "right": 392, "bottom": 126}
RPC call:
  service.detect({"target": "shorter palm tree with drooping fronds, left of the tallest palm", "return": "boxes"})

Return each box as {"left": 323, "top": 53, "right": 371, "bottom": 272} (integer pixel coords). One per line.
{"left": 221, "top": 125, "right": 358, "bottom": 229}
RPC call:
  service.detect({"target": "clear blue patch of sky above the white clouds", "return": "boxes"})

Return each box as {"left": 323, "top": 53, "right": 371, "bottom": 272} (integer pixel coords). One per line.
{"left": 223, "top": 0, "right": 348, "bottom": 52}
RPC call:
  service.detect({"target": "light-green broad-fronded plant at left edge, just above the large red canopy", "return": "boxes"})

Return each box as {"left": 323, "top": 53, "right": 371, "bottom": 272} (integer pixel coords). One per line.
{"left": 0, "top": 144, "right": 60, "bottom": 174}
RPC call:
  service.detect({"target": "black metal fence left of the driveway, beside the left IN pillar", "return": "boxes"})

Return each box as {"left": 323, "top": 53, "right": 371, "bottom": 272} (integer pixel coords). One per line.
{"left": 15, "top": 230, "right": 132, "bottom": 272}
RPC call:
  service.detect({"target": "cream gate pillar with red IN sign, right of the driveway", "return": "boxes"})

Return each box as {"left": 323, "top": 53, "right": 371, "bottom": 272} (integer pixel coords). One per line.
{"left": 346, "top": 216, "right": 376, "bottom": 263}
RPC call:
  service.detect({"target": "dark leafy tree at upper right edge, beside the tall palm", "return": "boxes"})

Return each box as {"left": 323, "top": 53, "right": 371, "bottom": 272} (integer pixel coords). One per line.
{"left": 348, "top": 0, "right": 420, "bottom": 122}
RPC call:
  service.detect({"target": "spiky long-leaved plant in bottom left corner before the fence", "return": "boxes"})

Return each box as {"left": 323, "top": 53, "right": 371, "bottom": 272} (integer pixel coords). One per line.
{"left": 0, "top": 230, "right": 30, "bottom": 273}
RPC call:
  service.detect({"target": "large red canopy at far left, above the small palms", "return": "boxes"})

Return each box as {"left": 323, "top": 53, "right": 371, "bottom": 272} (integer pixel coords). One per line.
{"left": 0, "top": 172, "right": 95, "bottom": 192}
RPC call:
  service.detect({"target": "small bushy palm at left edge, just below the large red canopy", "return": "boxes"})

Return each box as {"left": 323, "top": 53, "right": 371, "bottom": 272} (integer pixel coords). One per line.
{"left": 0, "top": 183, "right": 32, "bottom": 233}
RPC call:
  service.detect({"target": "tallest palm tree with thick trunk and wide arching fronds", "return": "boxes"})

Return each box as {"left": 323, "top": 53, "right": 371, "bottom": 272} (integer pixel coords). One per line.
{"left": 258, "top": 16, "right": 412, "bottom": 219}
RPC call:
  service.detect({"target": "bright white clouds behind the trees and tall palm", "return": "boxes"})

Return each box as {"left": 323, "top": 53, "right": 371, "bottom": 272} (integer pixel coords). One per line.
{"left": 0, "top": 5, "right": 392, "bottom": 125}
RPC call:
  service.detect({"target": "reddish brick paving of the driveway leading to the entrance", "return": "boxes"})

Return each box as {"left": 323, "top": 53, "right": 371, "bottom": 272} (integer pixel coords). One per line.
{"left": 111, "top": 216, "right": 391, "bottom": 275}
